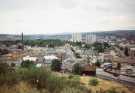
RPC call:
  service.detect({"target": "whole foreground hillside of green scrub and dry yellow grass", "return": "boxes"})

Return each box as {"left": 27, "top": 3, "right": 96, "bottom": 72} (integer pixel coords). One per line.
{"left": 0, "top": 62, "right": 133, "bottom": 93}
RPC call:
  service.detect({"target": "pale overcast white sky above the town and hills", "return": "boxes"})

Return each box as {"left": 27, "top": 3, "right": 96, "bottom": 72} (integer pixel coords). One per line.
{"left": 0, "top": 0, "right": 135, "bottom": 34}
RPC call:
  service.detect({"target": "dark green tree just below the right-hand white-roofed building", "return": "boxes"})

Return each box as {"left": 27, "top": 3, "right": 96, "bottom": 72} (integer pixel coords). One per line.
{"left": 51, "top": 59, "right": 62, "bottom": 71}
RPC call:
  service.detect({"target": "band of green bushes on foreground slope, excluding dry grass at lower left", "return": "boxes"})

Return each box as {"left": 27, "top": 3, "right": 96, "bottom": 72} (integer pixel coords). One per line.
{"left": 0, "top": 68, "right": 90, "bottom": 93}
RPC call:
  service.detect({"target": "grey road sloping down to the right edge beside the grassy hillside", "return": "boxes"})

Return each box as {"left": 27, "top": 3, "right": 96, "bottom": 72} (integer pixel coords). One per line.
{"left": 96, "top": 69, "right": 135, "bottom": 88}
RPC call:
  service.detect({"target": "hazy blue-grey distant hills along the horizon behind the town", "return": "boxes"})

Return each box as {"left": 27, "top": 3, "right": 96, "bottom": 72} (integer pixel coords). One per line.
{"left": 0, "top": 30, "right": 135, "bottom": 41}
